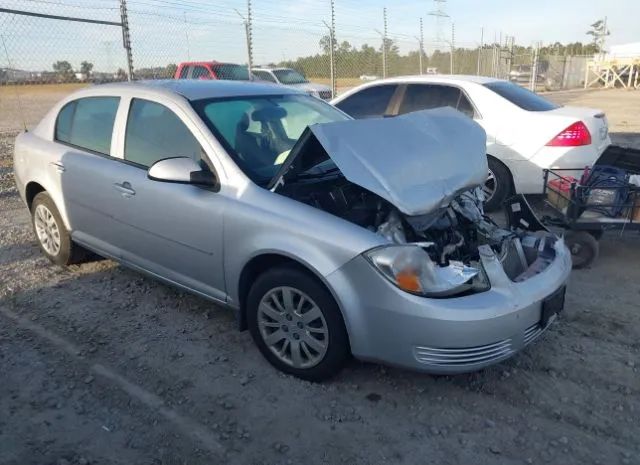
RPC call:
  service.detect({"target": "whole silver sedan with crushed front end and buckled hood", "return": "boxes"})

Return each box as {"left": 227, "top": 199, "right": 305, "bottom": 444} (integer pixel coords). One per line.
{"left": 15, "top": 81, "right": 571, "bottom": 380}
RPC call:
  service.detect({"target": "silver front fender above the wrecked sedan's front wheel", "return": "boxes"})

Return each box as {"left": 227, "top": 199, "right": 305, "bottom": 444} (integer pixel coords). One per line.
{"left": 223, "top": 186, "right": 387, "bottom": 306}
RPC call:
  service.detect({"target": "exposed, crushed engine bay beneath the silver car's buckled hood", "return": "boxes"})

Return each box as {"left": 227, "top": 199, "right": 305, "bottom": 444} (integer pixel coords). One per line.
{"left": 279, "top": 173, "right": 557, "bottom": 291}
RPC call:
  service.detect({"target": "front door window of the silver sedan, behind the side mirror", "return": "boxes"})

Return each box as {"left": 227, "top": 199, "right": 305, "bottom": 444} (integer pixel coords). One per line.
{"left": 124, "top": 99, "right": 202, "bottom": 167}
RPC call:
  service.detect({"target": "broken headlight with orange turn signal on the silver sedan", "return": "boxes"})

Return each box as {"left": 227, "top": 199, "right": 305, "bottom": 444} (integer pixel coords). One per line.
{"left": 365, "top": 244, "right": 489, "bottom": 297}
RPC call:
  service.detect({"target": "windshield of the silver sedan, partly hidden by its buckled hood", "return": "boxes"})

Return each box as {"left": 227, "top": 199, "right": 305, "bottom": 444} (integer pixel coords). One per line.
{"left": 192, "top": 94, "right": 349, "bottom": 185}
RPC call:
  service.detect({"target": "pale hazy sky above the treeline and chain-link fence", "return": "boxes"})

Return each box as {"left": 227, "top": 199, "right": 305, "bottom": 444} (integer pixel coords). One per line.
{"left": 0, "top": 0, "right": 640, "bottom": 71}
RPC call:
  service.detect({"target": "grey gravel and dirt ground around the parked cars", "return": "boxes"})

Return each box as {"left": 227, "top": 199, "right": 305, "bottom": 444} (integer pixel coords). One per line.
{"left": 0, "top": 85, "right": 640, "bottom": 465}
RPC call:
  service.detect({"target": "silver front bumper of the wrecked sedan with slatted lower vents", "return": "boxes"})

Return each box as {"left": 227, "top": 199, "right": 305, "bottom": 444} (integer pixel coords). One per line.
{"left": 327, "top": 240, "right": 571, "bottom": 374}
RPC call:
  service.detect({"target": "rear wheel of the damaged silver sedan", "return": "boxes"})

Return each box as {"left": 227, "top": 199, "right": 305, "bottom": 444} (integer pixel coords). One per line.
{"left": 31, "top": 192, "right": 88, "bottom": 266}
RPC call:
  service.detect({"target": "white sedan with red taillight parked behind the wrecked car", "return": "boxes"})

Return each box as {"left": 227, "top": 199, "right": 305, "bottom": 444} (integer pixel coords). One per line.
{"left": 331, "top": 75, "right": 611, "bottom": 210}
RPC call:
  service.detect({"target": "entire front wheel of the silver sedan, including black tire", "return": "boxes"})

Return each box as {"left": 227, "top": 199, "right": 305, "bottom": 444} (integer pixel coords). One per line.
{"left": 246, "top": 266, "right": 350, "bottom": 382}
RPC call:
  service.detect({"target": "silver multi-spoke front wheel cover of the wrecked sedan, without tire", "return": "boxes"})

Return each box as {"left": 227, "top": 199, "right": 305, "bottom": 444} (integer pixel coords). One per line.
{"left": 258, "top": 286, "right": 329, "bottom": 368}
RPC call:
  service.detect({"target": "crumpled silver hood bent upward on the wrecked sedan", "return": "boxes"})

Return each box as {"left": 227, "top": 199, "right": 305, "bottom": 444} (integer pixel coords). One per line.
{"left": 309, "top": 108, "right": 488, "bottom": 216}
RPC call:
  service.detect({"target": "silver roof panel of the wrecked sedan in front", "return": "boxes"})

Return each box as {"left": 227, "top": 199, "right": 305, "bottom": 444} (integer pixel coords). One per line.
{"left": 83, "top": 79, "right": 300, "bottom": 100}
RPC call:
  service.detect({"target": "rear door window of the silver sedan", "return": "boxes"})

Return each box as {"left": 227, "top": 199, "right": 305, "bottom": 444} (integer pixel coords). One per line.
{"left": 55, "top": 97, "right": 120, "bottom": 155}
